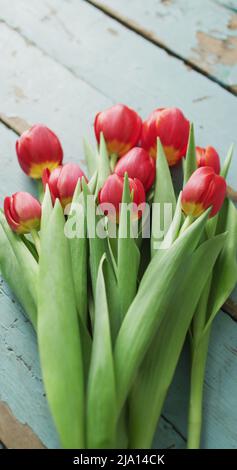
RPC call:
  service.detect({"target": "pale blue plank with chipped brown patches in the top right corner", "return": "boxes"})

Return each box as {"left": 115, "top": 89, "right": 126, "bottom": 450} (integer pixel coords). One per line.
{"left": 85, "top": 0, "right": 237, "bottom": 93}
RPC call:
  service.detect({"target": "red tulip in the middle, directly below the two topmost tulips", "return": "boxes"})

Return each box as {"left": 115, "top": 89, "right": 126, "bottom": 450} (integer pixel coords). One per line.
{"left": 114, "top": 147, "right": 156, "bottom": 191}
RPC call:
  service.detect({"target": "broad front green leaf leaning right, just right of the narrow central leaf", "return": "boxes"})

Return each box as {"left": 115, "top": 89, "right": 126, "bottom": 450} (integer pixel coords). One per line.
{"left": 114, "top": 212, "right": 208, "bottom": 409}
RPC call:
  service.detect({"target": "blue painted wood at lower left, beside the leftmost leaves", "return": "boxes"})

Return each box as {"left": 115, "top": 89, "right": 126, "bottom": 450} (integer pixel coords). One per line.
{"left": 0, "top": 279, "right": 59, "bottom": 448}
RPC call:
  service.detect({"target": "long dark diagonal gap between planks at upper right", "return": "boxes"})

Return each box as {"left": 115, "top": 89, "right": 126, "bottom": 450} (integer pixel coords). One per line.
{"left": 83, "top": 0, "right": 237, "bottom": 96}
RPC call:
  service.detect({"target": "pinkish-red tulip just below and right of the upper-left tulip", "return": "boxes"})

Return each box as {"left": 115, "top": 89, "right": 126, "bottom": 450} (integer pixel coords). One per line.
{"left": 42, "top": 163, "right": 87, "bottom": 207}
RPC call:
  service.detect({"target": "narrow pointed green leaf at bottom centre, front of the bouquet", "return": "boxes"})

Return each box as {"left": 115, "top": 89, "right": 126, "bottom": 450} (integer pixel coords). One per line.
{"left": 87, "top": 257, "right": 117, "bottom": 449}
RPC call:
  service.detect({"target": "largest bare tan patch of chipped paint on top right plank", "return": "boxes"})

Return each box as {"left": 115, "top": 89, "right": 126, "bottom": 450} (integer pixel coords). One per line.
{"left": 193, "top": 31, "right": 237, "bottom": 72}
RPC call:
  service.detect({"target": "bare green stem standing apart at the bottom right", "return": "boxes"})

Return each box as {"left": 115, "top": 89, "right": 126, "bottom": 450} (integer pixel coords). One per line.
{"left": 187, "top": 330, "right": 210, "bottom": 449}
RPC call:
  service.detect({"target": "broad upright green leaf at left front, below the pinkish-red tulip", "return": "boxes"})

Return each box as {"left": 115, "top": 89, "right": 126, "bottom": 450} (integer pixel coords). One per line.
{"left": 38, "top": 200, "right": 85, "bottom": 449}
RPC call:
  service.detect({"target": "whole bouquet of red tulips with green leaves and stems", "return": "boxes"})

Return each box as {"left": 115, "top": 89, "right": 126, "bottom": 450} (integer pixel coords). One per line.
{"left": 0, "top": 105, "right": 237, "bottom": 448}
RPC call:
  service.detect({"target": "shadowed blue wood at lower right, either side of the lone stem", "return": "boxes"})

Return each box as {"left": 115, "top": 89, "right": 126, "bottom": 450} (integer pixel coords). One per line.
{"left": 164, "top": 314, "right": 237, "bottom": 449}
